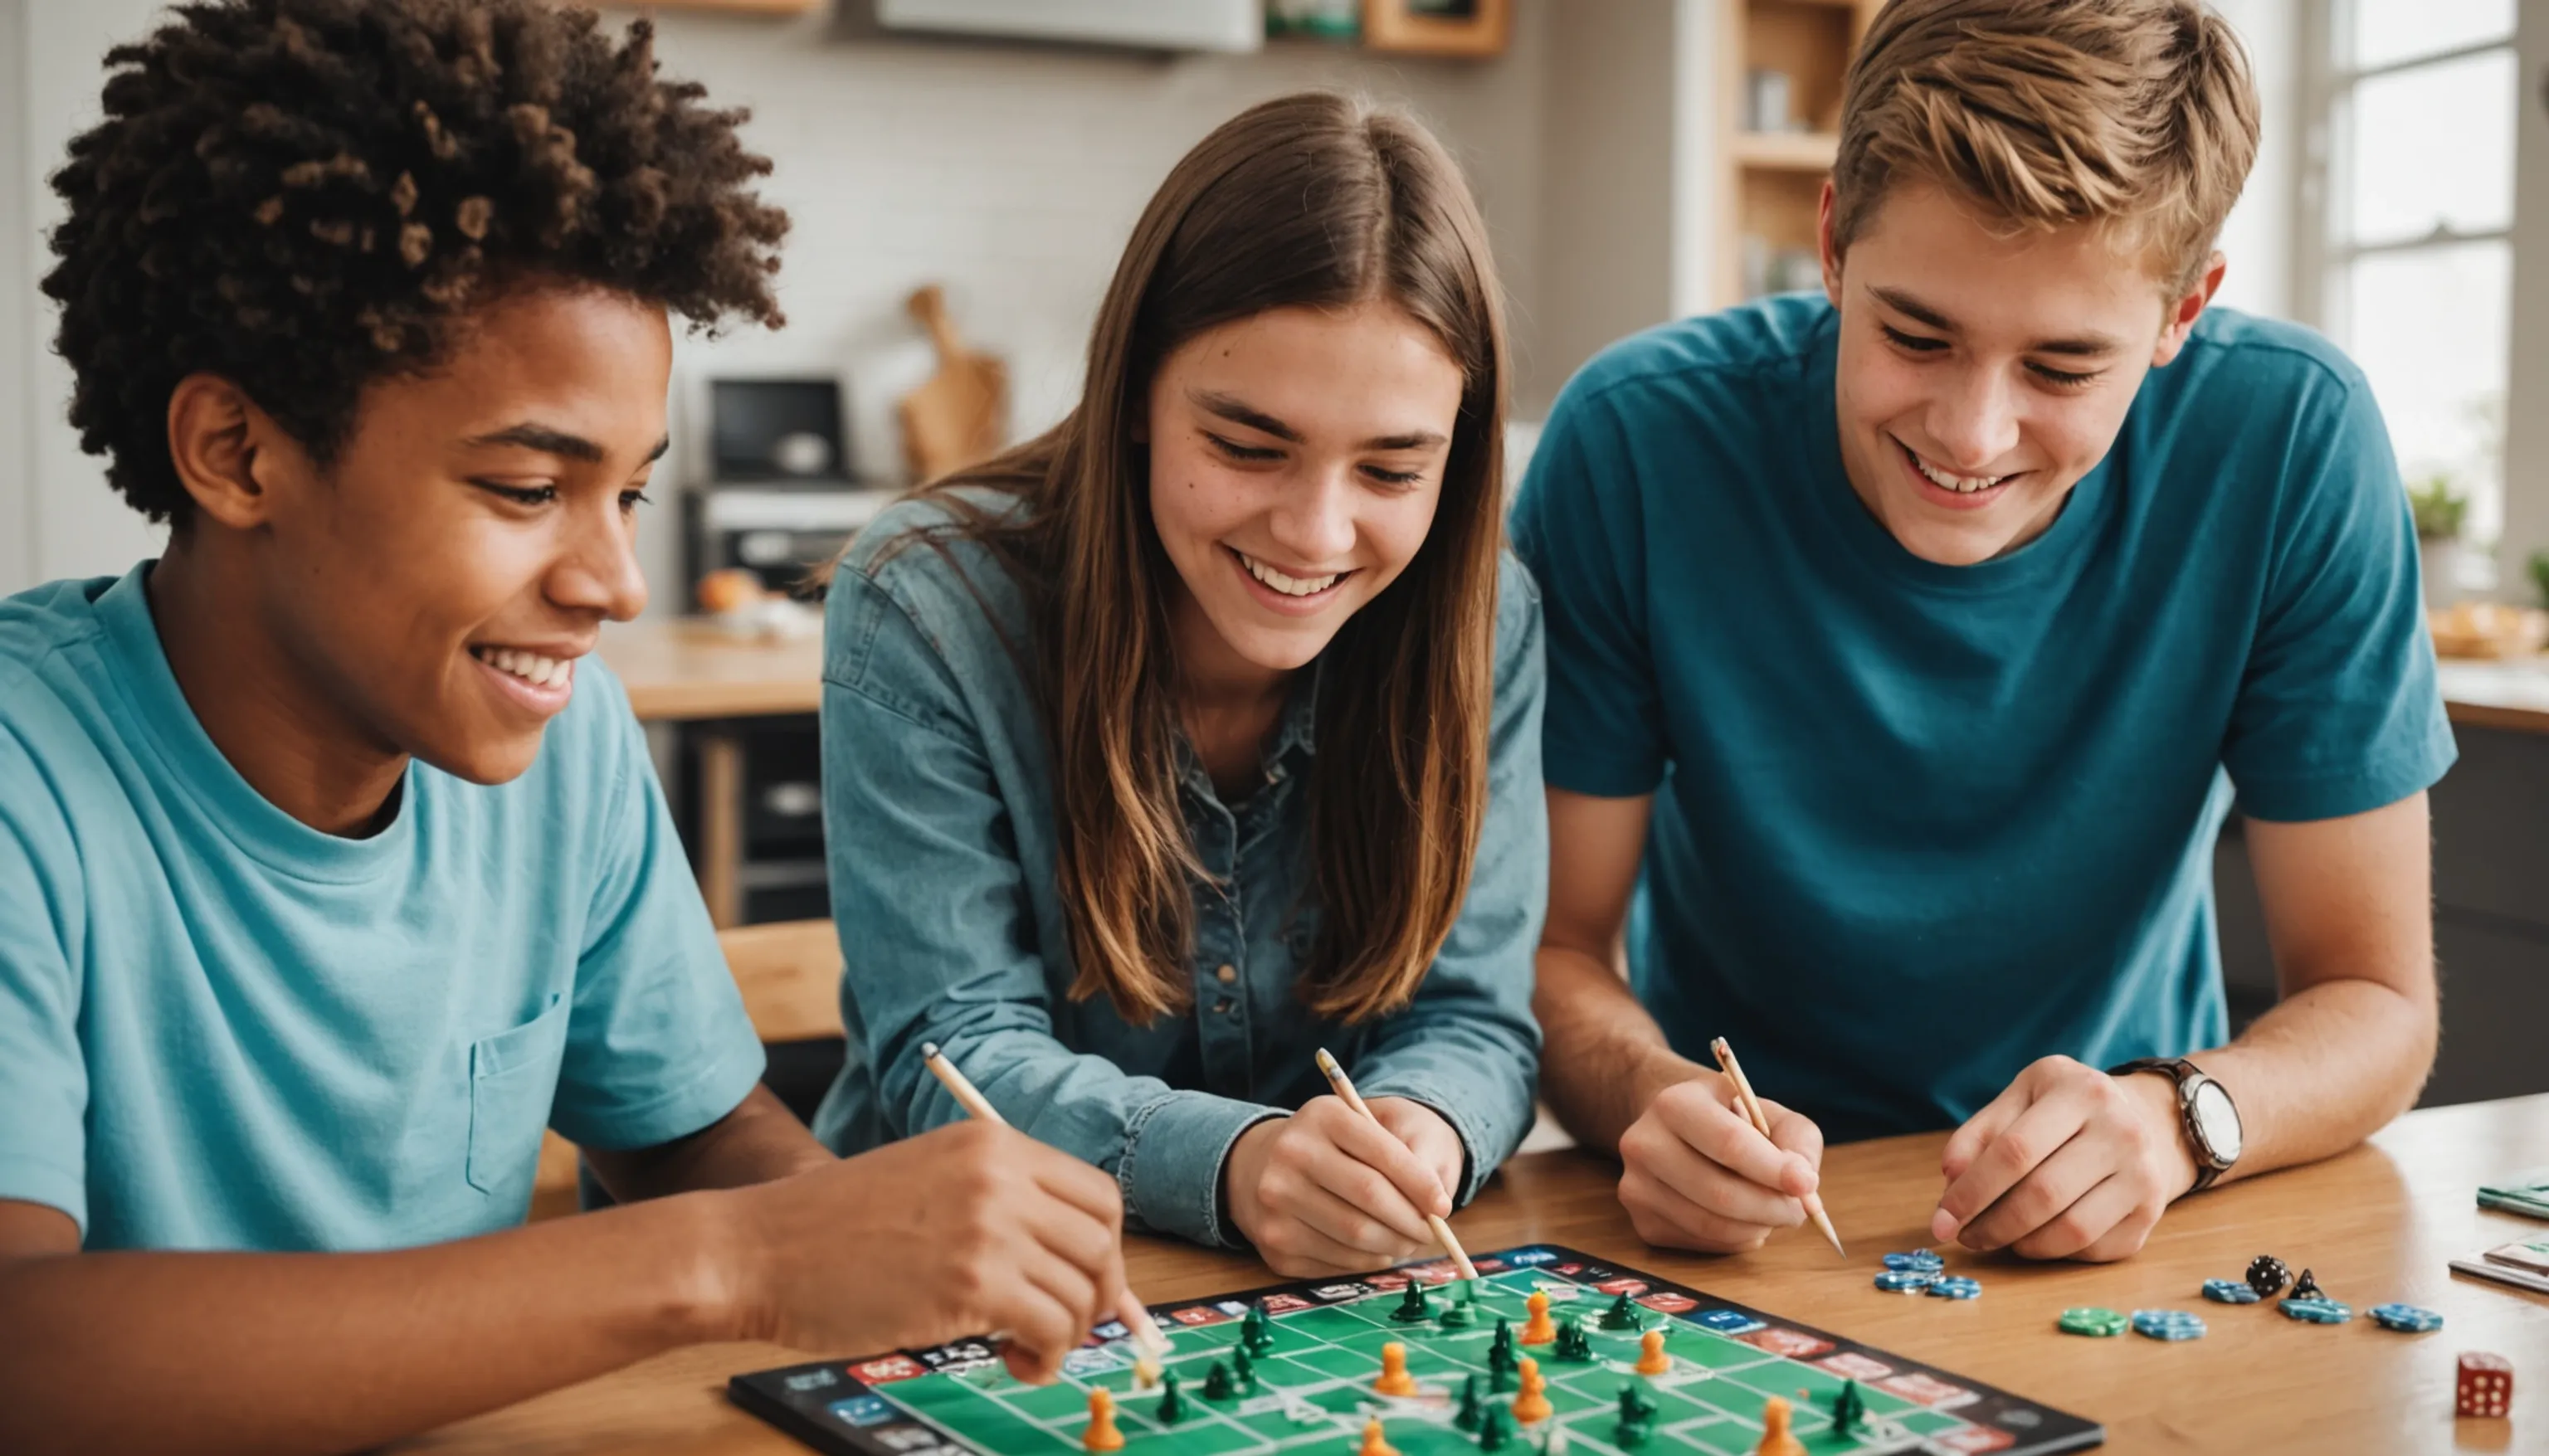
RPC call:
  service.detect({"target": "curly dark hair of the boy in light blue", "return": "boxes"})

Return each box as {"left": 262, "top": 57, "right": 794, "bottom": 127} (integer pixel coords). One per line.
{"left": 43, "top": 0, "right": 787, "bottom": 523}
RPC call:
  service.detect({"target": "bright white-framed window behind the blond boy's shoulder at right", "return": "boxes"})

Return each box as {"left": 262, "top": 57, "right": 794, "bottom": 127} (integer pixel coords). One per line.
{"left": 2297, "top": 0, "right": 2521, "bottom": 541}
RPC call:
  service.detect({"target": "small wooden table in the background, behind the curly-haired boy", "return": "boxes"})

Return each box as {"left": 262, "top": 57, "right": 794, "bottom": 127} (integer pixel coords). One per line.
{"left": 602, "top": 620, "right": 823, "bottom": 928}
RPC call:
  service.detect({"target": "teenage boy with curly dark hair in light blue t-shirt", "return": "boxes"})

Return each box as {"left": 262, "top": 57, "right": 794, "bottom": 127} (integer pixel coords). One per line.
{"left": 0, "top": 0, "right": 1122, "bottom": 1454}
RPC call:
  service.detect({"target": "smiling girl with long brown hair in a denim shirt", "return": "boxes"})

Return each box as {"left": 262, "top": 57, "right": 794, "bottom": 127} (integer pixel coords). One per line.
{"left": 816, "top": 95, "right": 1547, "bottom": 1273}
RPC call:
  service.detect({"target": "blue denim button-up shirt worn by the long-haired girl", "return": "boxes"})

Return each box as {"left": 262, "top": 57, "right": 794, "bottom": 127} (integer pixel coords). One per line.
{"left": 816, "top": 497, "right": 1547, "bottom": 1244}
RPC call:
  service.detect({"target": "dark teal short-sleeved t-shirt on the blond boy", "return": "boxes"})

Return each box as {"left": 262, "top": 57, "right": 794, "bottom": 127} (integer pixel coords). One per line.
{"left": 1514, "top": 296, "right": 2452, "bottom": 1140}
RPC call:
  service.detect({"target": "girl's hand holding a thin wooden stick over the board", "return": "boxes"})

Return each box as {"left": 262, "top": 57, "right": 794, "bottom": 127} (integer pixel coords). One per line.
{"left": 1221, "top": 1097, "right": 1460, "bottom": 1278}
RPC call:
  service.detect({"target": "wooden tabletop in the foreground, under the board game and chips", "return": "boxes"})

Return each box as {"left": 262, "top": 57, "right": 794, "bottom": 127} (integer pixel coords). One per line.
{"left": 395, "top": 1097, "right": 2549, "bottom": 1456}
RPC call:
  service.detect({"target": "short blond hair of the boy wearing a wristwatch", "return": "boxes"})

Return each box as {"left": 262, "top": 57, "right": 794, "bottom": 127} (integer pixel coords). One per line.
{"left": 1833, "top": 0, "right": 2259, "bottom": 290}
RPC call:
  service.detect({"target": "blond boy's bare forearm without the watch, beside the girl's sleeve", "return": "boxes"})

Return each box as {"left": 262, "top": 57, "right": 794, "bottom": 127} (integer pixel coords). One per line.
{"left": 1532, "top": 943, "right": 1703, "bottom": 1152}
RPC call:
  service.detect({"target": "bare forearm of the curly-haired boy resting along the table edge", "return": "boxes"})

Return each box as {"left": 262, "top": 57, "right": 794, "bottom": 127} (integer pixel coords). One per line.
{"left": 0, "top": 1193, "right": 749, "bottom": 1456}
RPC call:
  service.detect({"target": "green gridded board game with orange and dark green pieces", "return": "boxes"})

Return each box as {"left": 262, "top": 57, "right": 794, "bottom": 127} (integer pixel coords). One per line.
{"left": 727, "top": 1244, "right": 2105, "bottom": 1456}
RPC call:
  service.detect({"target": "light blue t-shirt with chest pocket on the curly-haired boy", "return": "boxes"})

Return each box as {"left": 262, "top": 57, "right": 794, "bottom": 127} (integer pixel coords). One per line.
{"left": 0, "top": 563, "right": 763, "bottom": 1249}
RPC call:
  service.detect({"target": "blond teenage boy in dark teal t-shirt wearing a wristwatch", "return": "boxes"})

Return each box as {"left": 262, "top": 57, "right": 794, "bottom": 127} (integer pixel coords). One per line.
{"left": 1514, "top": 0, "right": 2452, "bottom": 1259}
